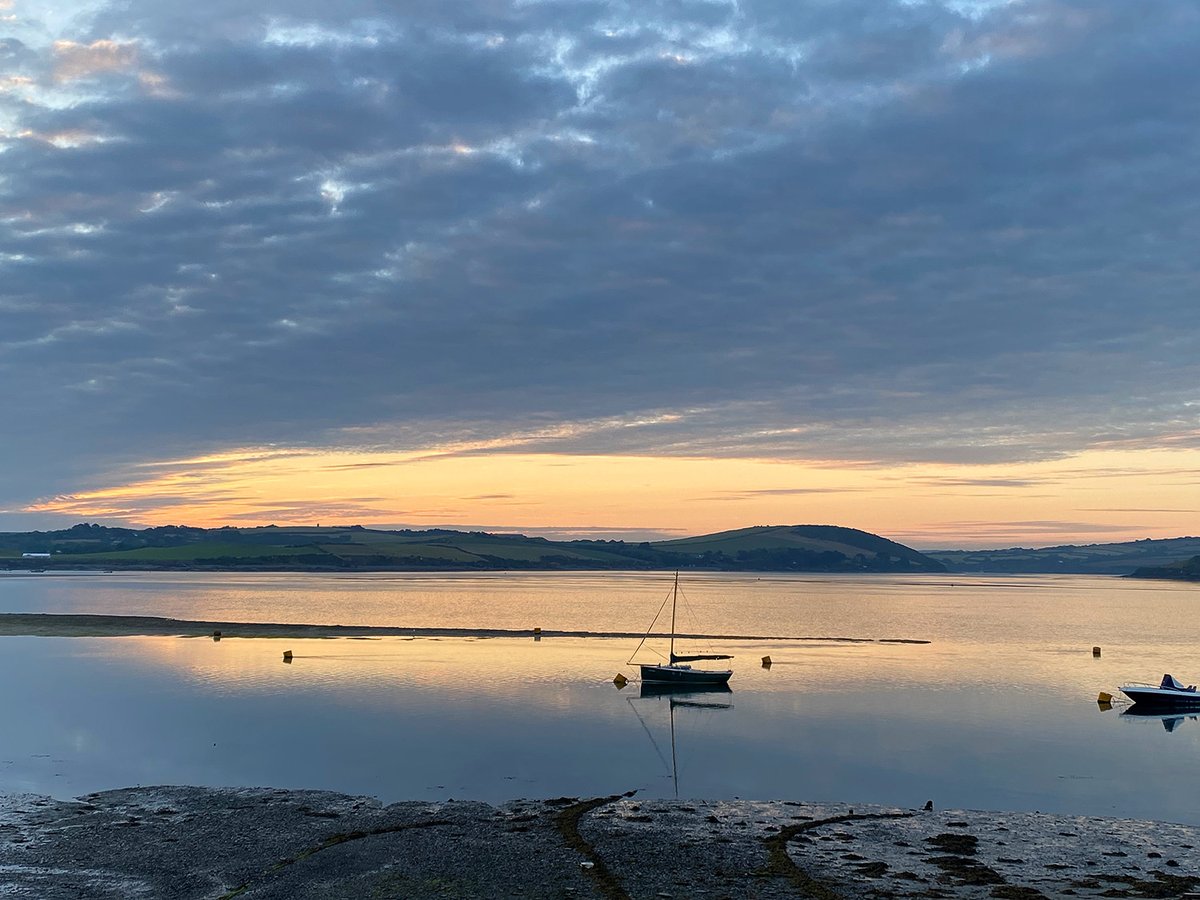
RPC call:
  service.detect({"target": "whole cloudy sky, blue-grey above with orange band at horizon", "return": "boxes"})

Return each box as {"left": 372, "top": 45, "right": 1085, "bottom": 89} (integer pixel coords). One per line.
{"left": 0, "top": 0, "right": 1200, "bottom": 548}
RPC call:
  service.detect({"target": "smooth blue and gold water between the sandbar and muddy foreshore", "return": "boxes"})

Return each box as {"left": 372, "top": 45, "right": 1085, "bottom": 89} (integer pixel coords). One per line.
{"left": 0, "top": 637, "right": 1200, "bottom": 821}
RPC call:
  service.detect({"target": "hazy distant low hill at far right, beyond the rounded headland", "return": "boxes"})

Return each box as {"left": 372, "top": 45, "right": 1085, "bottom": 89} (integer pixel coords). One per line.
{"left": 926, "top": 538, "right": 1200, "bottom": 577}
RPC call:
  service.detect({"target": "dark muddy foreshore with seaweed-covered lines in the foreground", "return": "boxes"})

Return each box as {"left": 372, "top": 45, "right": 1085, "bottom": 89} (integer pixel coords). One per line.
{"left": 0, "top": 787, "right": 1200, "bottom": 900}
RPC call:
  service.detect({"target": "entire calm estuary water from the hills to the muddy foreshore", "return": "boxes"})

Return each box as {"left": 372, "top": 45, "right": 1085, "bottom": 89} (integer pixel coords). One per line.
{"left": 0, "top": 574, "right": 1200, "bottom": 823}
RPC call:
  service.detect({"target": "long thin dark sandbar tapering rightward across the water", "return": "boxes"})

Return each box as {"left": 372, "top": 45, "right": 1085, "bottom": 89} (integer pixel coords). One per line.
{"left": 0, "top": 612, "right": 932, "bottom": 644}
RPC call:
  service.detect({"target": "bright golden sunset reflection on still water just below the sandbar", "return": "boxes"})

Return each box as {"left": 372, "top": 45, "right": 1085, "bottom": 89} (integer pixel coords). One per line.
{"left": 74, "top": 636, "right": 1190, "bottom": 704}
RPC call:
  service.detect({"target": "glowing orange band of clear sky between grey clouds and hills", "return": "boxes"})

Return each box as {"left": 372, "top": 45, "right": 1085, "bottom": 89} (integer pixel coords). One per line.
{"left": 24, "top": 448, "right": 1200, "bottom": 548}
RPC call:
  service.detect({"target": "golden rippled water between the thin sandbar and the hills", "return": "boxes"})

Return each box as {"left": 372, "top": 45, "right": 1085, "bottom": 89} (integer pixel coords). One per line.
{"left": 9, "top": 572, "right": 1200, "bottom": 672}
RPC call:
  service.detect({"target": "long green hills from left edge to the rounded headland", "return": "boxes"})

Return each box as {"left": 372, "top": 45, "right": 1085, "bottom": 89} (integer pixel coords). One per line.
{"left": 0, "top": 523, "right": 943, "bottom": 572}
